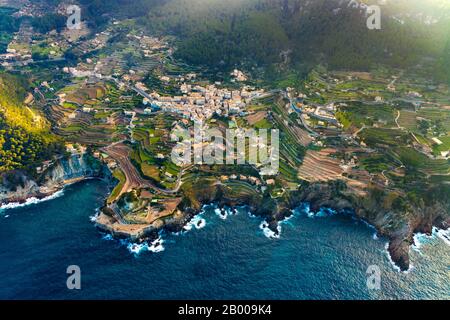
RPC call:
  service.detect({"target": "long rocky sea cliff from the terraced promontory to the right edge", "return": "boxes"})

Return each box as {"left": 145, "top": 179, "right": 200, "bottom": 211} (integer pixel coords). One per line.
{"left": 93, "top": 165, "right": 450, "bottom": 271}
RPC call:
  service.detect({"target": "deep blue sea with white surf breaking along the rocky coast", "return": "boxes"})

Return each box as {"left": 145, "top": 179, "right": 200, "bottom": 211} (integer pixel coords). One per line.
{"left": 0, "top": 180, "right": 450, "bottom": 299}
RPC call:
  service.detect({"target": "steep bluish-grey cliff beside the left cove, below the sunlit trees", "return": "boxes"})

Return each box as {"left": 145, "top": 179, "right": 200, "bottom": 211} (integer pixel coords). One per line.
{"left": 0, "top": 153, "right": 110, "bottom": 204}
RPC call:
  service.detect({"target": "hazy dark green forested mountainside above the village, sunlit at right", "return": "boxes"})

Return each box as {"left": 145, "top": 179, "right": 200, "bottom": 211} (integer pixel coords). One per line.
{"left": 141, "top": 0, "right": 450, "bottom": 76}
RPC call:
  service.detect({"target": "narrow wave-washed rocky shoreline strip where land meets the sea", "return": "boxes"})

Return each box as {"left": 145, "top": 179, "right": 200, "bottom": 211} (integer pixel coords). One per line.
{"left": 0, "top": 176, "right": 450, "bottom": 273}
